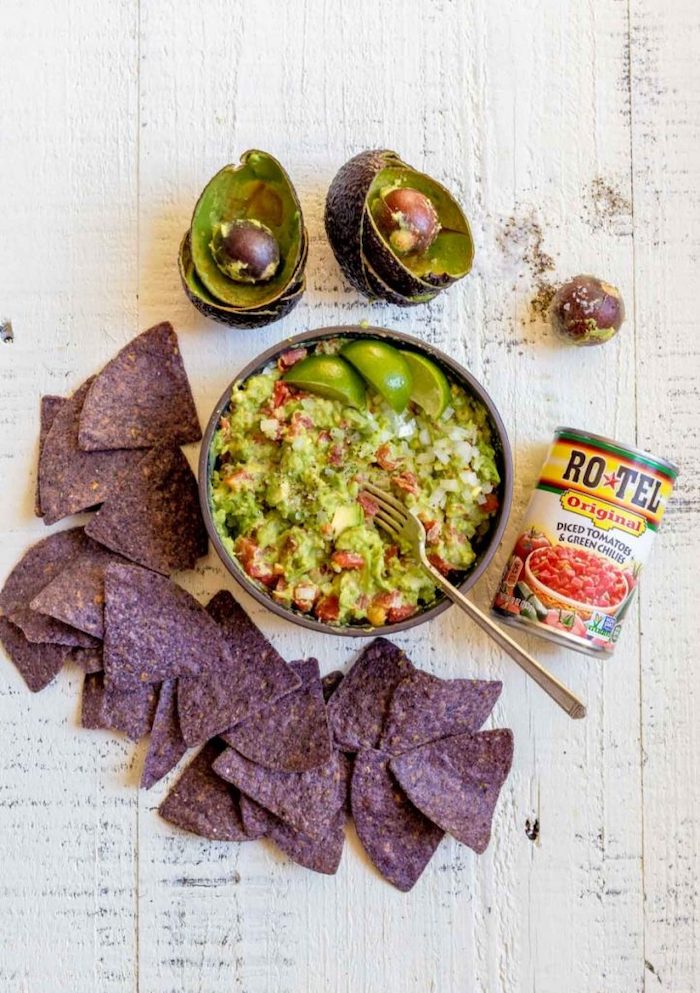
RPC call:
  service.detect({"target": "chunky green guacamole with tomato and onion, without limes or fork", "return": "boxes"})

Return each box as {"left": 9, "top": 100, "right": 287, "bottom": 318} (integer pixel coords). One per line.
{"left": 210, "top": 339, "right": 499, "bottom": 626}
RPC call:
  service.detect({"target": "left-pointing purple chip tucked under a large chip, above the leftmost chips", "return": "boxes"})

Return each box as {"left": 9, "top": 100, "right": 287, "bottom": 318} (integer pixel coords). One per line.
{"left": 31, "top": 540, "right": 125, "bottom": 638}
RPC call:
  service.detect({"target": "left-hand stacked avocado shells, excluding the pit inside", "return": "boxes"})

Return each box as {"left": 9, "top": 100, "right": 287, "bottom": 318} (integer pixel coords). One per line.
{"left": 178, "top": 149, "right": 308, "bottom": 328}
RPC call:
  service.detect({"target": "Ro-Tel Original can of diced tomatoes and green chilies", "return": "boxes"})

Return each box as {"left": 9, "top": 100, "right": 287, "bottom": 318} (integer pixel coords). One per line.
{"left": 492, "top": 428, "right": 678, "bottom": 655}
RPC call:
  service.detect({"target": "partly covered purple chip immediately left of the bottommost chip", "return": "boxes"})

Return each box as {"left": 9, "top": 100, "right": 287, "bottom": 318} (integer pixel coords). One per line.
{"left": 241, "top": 794, "right": 345, "bottom": 876}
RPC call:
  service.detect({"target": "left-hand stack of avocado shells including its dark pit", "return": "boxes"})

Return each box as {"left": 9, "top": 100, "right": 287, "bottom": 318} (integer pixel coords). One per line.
{"left": 179, "top": 149, "right": 308, "bottom": 327}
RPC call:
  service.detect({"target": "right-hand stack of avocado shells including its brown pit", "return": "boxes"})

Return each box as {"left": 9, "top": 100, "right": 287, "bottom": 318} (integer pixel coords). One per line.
{"left": 325, "top": 149, "right": 474, "bottom": 306}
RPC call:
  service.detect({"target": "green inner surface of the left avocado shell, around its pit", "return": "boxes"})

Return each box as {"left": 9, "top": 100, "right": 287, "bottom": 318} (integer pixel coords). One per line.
{"left": 188, "top": 151, "right": 303, "bottom": 310}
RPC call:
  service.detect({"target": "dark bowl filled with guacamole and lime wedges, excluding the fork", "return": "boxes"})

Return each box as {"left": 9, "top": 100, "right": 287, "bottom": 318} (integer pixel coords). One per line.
{"left": 199, "top": 326, "right": 512, "bottom": 636}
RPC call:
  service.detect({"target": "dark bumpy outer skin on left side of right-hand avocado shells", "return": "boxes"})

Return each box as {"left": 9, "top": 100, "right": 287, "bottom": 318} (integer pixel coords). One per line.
{"left": 325, "top": 148, "right": 401, "bottom": 297}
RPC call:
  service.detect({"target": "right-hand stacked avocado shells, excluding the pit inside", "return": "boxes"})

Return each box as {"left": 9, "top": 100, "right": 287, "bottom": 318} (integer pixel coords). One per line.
{"left": 325, "top": 149, "right": 474, "bottom": 306}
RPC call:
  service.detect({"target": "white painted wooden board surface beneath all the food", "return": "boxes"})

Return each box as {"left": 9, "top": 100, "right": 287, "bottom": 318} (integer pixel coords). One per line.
{"left": 0, "top": 0, "right": 700, "bottom": 993}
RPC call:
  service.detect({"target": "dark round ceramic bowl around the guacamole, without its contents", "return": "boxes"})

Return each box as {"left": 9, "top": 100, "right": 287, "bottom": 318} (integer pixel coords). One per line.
{"left": 199, "top": 325, "right": 513, "bottom": 637}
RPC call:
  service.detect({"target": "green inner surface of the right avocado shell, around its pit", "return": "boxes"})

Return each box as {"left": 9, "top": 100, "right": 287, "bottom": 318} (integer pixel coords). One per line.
{"left": 366, "top": 165, "right": 474, "bottom": 279}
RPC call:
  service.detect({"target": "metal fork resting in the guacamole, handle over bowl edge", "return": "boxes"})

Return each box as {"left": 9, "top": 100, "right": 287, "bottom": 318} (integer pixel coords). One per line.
{"left": 362, "top": 483, "right": 586, "bottom": 719}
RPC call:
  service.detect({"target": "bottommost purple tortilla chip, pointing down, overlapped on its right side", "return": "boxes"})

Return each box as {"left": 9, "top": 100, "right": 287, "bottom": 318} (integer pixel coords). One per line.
{"left": 352, "top": 749, "right": 443, "bottom": 893}
